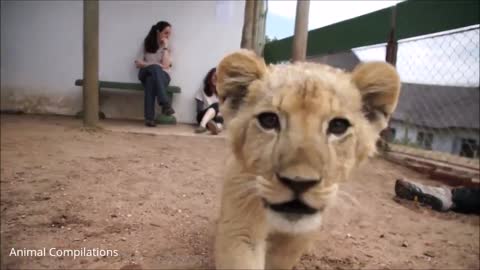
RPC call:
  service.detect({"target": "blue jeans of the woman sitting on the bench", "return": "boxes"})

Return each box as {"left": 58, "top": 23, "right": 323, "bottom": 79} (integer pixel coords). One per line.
{"left": 138, "top": 65, "right": 171, "bottom": 121}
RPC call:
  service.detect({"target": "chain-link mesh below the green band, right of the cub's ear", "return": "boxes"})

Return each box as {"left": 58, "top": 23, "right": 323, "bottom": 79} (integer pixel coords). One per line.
{"left": 388, "top": 26, "right": 480, "bottom": 167}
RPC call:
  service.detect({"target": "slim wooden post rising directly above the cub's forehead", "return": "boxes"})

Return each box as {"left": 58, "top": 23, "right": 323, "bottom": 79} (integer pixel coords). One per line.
{"left": 292, "top": 0, "right": 310, "bottom": 62}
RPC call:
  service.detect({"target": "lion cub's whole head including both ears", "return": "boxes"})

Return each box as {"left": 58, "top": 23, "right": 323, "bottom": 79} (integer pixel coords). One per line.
{"left": 217, "top": 50, "right": 400, "bottom": 232}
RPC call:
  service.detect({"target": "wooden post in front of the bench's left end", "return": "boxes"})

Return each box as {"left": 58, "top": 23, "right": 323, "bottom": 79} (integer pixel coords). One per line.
{"left": 83, "top": 0, "right": 99, "bottom": 127}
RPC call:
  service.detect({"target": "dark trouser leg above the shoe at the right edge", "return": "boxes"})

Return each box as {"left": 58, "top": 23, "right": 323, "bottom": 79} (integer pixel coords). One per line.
{"left": 452, "top": 187, "right": 480, "bottom": 213}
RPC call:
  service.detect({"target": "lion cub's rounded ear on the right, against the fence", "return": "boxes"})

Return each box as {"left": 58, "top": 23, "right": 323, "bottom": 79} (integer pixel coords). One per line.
{"left": 352, "top": 62, "right": 400, "bottom": 132}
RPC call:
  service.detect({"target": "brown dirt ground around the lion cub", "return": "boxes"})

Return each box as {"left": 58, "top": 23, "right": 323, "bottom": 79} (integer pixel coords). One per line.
{"left": 1, "top": 115, "right": 480, "bottom": 269}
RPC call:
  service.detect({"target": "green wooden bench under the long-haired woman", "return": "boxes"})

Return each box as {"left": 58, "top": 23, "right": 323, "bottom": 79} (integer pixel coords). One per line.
{"left": 75, "top": 79, "right": 182, "bottom": 124}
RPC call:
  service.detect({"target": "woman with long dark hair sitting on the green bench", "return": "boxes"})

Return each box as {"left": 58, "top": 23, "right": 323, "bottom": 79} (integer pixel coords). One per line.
{"left": 135, "top": 21, "right": 175, "bottom": 127}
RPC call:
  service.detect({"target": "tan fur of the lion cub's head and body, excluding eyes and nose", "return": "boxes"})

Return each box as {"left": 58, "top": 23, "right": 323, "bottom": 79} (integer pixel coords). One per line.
{"left": 215, "top": 50, "right": 400, "bottom": 269}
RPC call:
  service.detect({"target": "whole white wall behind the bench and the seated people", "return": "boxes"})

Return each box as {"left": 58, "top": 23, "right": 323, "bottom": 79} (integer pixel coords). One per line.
{"left": 1, "top": 1, "right": 244, "bottom": 122}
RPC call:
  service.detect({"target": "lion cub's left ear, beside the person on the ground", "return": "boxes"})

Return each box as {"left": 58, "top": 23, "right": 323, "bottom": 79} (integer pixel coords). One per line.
{"left": 217, "top": 49, "right": 267, "bottom": 117}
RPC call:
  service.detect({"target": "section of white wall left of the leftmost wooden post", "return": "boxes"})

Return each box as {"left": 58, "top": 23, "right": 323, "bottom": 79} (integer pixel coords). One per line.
{"left": 0, "top": 1, "right": 83, "bottom": 114}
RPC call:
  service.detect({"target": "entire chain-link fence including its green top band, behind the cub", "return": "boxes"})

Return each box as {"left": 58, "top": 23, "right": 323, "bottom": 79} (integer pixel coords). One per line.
{"left": 264, "top": 1, "right": 480, "bottom": 170}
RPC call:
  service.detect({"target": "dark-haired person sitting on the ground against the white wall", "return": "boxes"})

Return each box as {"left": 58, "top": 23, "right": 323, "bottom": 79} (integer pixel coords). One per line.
{"left": 195, "top": 68, "right": 223, "bottom": 135}
